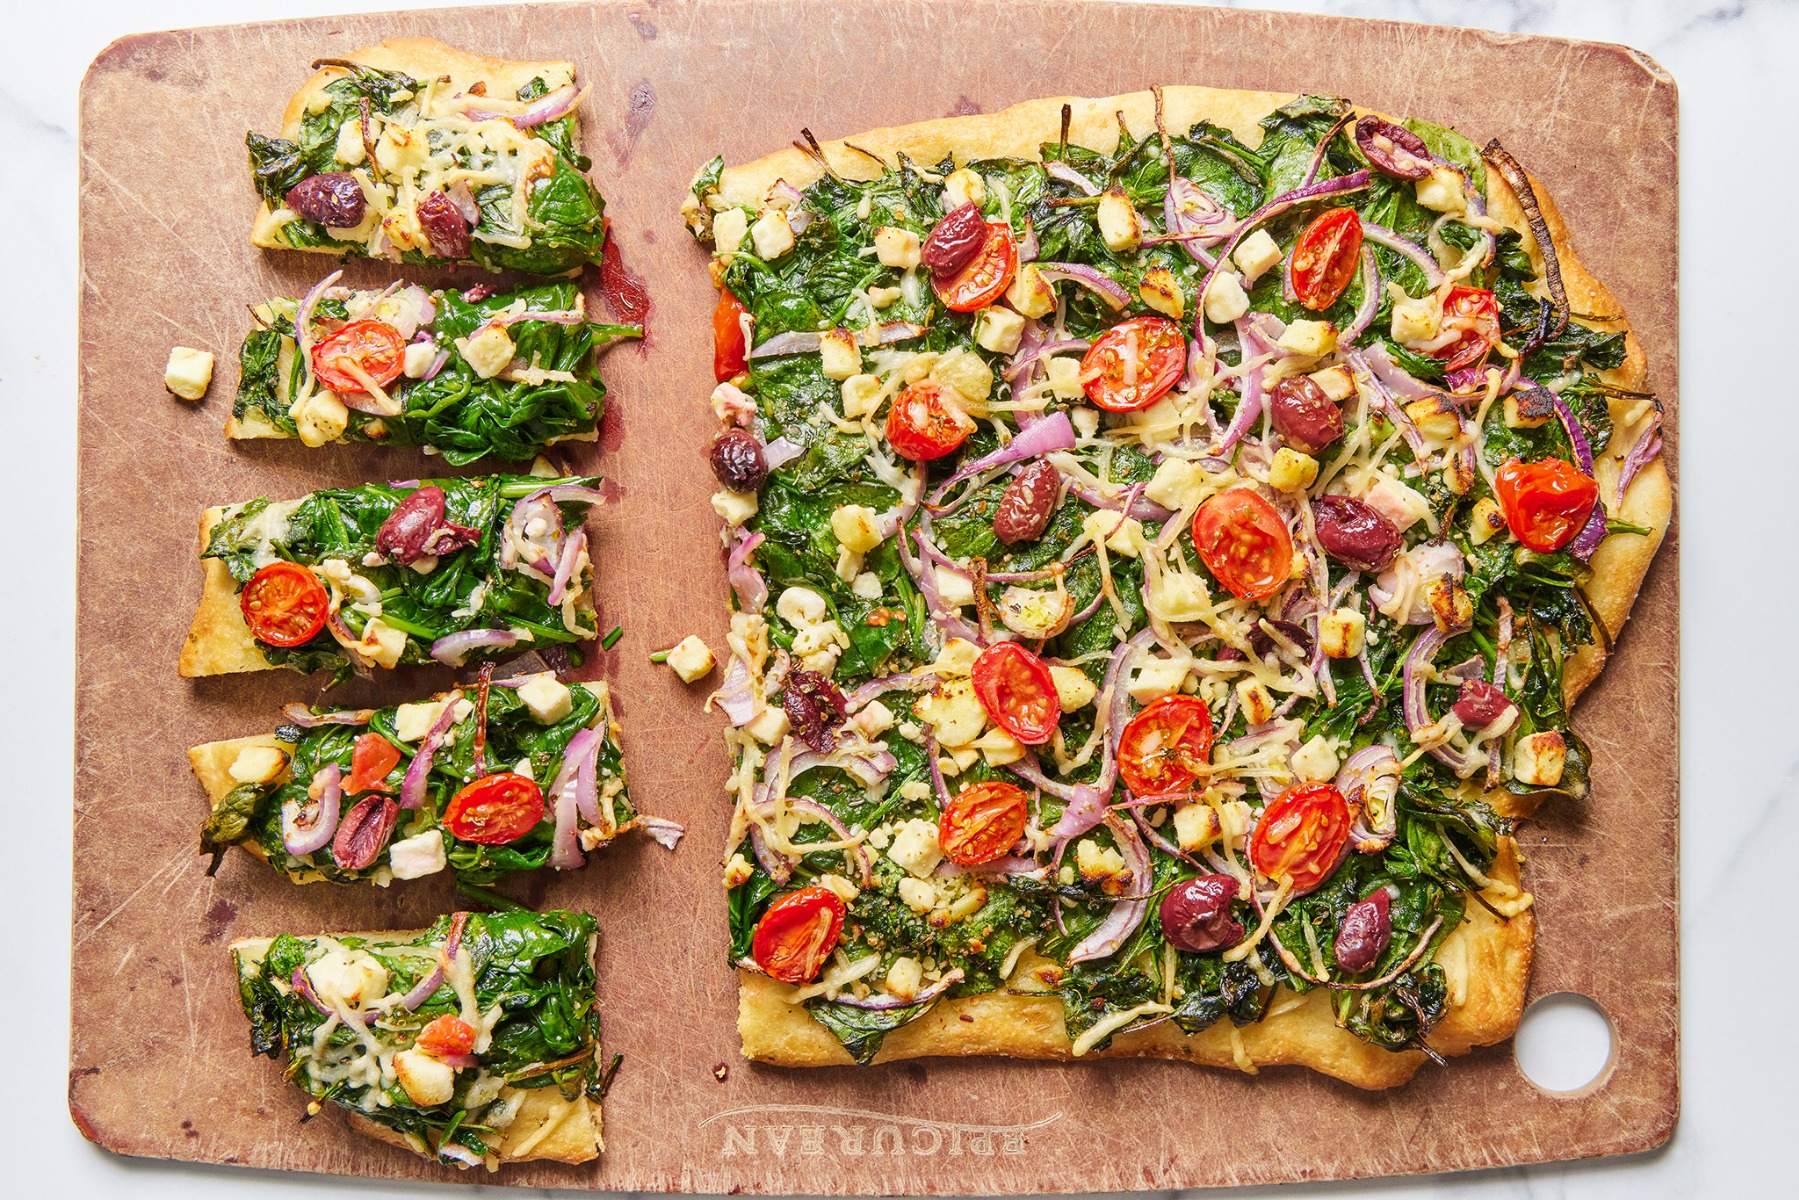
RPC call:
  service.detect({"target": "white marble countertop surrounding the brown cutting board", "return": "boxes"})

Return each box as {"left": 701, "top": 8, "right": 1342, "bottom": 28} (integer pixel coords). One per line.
{"left": 10, "top": 0, "right": 1799, "bottom": 1200}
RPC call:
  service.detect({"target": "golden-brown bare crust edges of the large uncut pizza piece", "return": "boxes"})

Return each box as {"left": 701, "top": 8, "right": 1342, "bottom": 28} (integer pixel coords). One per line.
{"left": 720, "top": 86, "right": 1673, "bottom": 1088}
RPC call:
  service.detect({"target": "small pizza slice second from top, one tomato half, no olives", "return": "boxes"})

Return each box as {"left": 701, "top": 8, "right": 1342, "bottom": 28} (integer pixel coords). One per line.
{"left": 235, "top": 272, "right": 642, "bottom": 466}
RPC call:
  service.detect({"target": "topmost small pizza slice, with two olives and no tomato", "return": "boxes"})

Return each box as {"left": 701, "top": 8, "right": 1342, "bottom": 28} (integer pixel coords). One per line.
{"left": 246, "top": 38, "right": 606, "bottom": 275}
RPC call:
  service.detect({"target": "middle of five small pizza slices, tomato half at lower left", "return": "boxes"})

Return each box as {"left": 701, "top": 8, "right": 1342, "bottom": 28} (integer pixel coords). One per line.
{"left": 180, "top": 475, "right": 603, "bottom": 676}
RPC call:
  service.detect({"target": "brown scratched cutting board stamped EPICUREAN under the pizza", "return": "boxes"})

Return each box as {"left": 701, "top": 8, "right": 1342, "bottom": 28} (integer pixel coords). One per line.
{"left": 68, "top": 0, "right": 1678, "bottom": 1195}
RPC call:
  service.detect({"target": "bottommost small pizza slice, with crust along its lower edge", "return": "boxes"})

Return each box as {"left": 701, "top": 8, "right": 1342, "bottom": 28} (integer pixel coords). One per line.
{"left": 230, "top": 910, "right": 606, "bottom": 1171}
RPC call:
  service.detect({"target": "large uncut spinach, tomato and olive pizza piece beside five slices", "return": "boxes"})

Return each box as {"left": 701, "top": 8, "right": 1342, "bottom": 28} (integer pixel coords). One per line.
{"left": 684, "top": 86, "right": 1671, "bottom": 1088}
